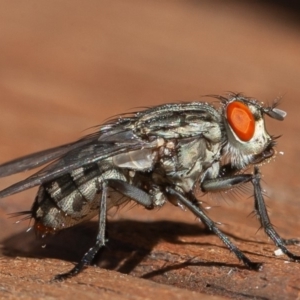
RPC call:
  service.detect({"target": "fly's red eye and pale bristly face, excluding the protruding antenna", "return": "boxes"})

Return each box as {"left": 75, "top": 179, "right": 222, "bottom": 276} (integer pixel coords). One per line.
{"left": 223, "top": 98, "right": 272, "bottom": 169}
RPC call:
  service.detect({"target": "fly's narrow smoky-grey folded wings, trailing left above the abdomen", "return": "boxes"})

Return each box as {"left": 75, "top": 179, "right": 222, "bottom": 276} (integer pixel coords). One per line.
{"left": 0, "top": 127, "right": 155, "bottom": 198}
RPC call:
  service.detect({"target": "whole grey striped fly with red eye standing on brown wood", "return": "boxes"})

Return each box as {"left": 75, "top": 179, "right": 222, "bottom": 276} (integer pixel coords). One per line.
{"left": 0, "top": 94, "right": 300, "bottom": 280}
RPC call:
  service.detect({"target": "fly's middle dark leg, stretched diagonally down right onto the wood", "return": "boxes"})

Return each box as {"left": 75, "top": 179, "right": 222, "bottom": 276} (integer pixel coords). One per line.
{"left": 166, "top": 187, "right": 261, "bottom": 270}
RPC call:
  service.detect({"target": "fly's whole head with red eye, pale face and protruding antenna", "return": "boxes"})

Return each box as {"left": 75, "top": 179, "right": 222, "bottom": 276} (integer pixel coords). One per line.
{"left": 220, "top": 94, "right": 286, "bottom": 169}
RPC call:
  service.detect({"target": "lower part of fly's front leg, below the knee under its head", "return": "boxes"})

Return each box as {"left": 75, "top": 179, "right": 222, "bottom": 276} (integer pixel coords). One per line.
{"left": 252, "top": 167, "right": 300, "bottom": 262}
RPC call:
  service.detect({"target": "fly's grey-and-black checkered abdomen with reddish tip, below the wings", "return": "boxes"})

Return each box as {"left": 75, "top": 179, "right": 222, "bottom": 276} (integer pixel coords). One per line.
{"left": 32, "top": 162, "right": 126, "bottom": 232}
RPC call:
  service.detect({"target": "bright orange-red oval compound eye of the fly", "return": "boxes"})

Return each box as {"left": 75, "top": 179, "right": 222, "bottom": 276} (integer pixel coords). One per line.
{"left": 227, "top": 101, "right": 255, "bottom": 142}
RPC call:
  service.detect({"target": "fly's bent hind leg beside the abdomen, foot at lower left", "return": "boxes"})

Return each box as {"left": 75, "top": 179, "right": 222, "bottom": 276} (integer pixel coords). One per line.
{"left": 54, "top": 179, "right": 153, "bottom": 281}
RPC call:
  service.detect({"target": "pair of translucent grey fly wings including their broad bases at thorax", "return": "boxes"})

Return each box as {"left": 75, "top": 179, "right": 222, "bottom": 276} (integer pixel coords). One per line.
{"left": 0, "top": 116, "right": 153, "bottom": 198}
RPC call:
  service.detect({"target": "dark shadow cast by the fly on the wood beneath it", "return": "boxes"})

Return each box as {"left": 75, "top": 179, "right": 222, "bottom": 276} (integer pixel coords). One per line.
{"left": 1, "top": 220, "right": 268, "bottom": 278}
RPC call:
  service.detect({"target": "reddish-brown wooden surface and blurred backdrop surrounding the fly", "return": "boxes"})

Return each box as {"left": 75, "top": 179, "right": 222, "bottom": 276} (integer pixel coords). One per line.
{"left": 0, "top": 0, "right": 300, "bottom": 299}
